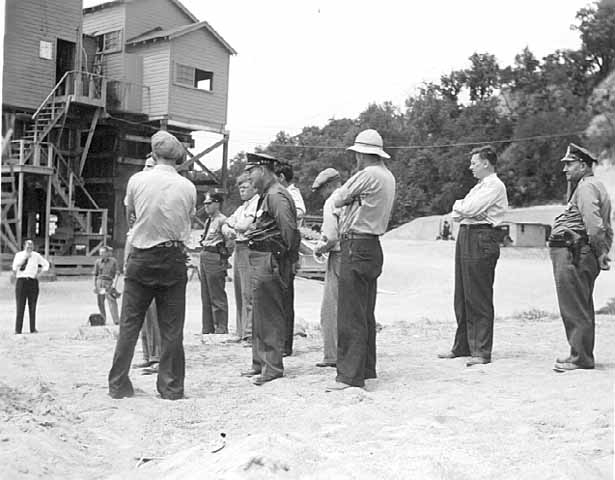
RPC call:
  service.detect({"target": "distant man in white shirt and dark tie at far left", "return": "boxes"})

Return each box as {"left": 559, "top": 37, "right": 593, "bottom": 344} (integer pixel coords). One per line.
{"left": 13, "top": 240, "right": 49, "bottom": 334}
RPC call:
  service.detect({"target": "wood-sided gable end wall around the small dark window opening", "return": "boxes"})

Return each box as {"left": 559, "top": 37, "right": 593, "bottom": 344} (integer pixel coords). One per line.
{"left": 169, "top": 29, "right": 230, "bottom": 130}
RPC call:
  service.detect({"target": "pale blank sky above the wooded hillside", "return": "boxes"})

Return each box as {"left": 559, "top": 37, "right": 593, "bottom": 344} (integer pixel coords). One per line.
{"left": 84, "top": 0, "right": 589, "bottom": 168}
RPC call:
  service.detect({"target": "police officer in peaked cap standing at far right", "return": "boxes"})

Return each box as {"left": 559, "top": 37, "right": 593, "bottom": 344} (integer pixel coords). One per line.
{"left": 549, "top": 143, "right": 613, "bottom": 372}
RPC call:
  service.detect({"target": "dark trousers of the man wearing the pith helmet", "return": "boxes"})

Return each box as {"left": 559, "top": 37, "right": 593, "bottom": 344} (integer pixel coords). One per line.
{"left": 336, "top": 237, "right": 383, "bottom": 387}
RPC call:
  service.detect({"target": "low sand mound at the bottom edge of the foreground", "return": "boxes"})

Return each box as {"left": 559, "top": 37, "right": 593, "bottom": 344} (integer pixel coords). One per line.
{"left": 124, "top": 434, "right": 332, "bottom": 480}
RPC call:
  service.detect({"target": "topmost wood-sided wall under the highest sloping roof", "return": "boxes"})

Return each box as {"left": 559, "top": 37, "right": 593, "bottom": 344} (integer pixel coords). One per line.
{"left": 126, "top": 0, "right": 193, "bottom": 40}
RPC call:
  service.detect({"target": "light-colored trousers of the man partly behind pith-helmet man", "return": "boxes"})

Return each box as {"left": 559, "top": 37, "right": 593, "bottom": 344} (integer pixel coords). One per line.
{"left": 320, "top": 252, "right": 342, "bottom": 363}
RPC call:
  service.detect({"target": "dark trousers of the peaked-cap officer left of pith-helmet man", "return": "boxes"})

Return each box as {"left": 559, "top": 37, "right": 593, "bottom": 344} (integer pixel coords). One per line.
{"left": 248, "top": 250, "right": 286, "bottom": 378}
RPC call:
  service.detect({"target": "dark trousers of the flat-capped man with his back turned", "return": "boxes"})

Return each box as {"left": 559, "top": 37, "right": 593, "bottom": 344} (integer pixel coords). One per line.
{"left": 109, "top": 247, "right": 187, "bottom": 399}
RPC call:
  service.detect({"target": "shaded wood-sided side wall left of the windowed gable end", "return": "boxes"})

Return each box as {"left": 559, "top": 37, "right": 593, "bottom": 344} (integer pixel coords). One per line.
{"left": 129, "top": 41, "right": 171, "bottom": 117}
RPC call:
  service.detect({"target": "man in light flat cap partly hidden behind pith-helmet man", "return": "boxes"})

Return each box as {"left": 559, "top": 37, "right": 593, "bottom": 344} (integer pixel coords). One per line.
{"left": 312, "top": 168, "right": 344, "bottom": 367}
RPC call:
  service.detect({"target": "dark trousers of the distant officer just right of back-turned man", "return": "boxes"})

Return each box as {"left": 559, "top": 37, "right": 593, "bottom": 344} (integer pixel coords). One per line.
{"left": 200, "top": 252, "right": 228, "bottom": 333}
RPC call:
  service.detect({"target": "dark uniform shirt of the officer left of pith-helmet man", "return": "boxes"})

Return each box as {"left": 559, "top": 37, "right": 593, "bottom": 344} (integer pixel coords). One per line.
{"left": 246, "top": 182, "right": 301, "bottom": 259}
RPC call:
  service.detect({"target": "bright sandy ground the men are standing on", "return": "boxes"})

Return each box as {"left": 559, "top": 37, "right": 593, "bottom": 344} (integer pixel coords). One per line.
{"left": 0, "top": 240, "right": 615, "bottom": 480}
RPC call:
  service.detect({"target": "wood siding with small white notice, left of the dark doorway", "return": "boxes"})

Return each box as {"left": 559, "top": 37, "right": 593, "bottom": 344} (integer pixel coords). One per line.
{"left": 2, "top": 0, "right": 82, "bottom": 109}
